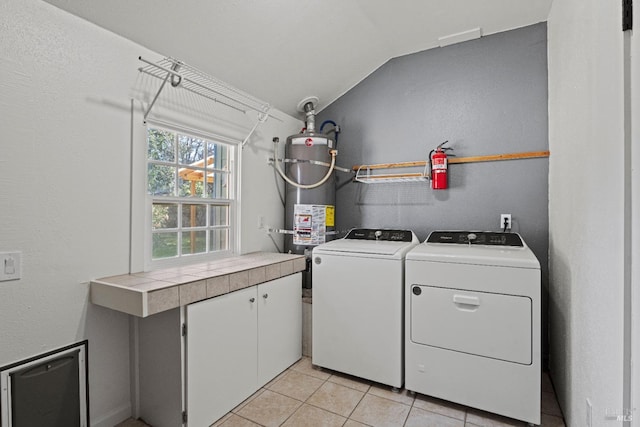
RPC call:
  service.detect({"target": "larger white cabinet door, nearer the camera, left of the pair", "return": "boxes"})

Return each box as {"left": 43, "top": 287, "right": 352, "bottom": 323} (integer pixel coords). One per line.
{"left": 186, "top": 287, "right": 258, "bottom": 427}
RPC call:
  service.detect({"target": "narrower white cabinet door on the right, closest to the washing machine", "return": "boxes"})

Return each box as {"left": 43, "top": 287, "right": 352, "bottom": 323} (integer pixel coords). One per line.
{"left": 258, "top": 273, "right": 302, "bottom": 387}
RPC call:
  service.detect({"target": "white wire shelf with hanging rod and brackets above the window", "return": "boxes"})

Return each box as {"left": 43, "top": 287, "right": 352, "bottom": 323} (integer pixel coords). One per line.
{"left": 138, "top": 56, "right": 282, "bottom": 146}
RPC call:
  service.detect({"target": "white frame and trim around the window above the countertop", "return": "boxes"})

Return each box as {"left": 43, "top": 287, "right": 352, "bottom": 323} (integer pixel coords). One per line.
{"left": 136, "top": 120, "right": 241, "bottom": 272}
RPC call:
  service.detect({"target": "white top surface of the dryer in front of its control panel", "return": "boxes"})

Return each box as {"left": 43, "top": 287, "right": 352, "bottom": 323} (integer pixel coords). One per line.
{"left": 406, "top": 232, "right": 540, "bottom": 269}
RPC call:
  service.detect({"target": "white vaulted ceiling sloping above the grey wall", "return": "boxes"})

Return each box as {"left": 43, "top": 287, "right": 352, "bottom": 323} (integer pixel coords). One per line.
{"left": 45, "top": 0, "right": 553, "bottom": 116}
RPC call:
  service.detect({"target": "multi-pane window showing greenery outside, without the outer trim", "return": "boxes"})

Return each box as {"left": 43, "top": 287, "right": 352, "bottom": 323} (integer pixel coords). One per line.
{"left": 147, "top": 126, "right": 235, "bottom": 262}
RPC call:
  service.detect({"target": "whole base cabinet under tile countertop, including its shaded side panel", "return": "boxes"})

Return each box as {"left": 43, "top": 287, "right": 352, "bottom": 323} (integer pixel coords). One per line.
{"left": 138, "top": 273, "right": 302, "bottom": 427}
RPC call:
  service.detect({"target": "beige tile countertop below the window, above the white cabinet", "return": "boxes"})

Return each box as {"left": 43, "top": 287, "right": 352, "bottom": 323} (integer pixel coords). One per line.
{"left": 90, "top": 252, "right": 306, "bottom": 317}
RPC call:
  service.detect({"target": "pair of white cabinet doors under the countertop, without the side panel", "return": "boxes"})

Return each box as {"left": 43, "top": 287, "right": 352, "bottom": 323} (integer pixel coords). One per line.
{"left": 187, "top": 273, "right": 302, "bottom": 426}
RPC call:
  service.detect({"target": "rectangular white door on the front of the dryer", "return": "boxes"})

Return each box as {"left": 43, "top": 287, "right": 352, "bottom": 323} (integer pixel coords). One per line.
{"left": 410, "top": 285, "right": 532, "bottom": 365}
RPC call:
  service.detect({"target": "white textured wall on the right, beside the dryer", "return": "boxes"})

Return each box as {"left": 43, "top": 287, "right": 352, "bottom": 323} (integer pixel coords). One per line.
{"left": 548, "top": 0, "right": 625, "bottom": 426}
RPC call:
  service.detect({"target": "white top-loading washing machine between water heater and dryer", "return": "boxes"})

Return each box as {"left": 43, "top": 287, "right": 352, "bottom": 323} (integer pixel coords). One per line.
{"left": 312, "top": 229, "right": 419, "bottom": 388}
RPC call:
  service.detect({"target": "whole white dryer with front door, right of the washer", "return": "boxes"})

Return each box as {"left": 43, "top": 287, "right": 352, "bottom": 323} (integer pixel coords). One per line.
{"left": 405, "top": 231, "right": 541, "bottom": 424}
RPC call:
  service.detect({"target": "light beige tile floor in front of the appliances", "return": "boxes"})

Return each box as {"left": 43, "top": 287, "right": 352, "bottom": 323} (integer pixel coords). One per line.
{"left": 117, "top": 357, "right": 565, "bottom": 427}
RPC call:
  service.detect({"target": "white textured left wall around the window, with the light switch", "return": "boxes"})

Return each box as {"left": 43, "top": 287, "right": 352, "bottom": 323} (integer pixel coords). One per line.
{"left": 0, "top": 0, "right": 300, "bottom": 426}
